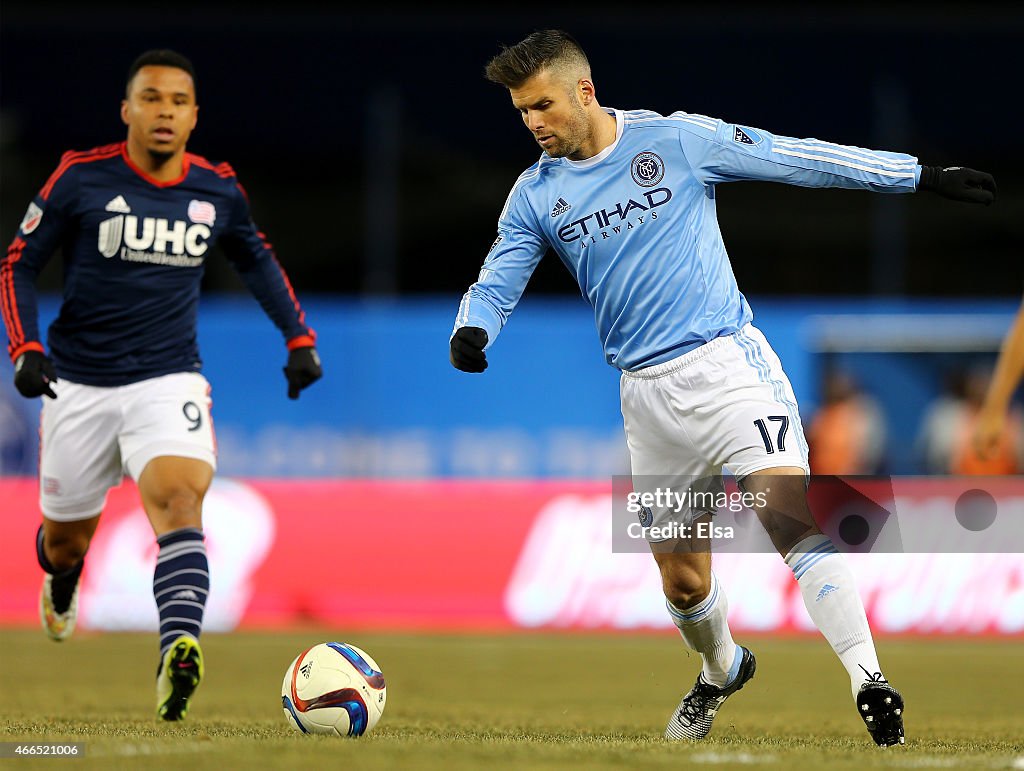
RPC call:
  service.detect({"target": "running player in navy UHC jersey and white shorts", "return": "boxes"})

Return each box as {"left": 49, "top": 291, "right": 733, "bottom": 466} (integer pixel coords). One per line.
{"left": 0, "top": 50, "right": 321, "bottom": 721}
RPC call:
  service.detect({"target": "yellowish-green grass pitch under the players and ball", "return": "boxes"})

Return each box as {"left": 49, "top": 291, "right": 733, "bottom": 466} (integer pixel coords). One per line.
{"left": 0, "top": 630, "right": 1024, "bottom": 771}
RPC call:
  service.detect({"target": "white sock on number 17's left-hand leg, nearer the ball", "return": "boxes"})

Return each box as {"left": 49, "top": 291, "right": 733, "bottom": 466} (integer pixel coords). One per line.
{"left": 665, "top": 572, "right": 742, "bottom": 686}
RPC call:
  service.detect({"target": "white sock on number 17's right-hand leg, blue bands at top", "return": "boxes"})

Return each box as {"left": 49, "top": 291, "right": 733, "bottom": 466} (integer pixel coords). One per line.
{"left": 785, "top": 534, "right": 882, "bottom": 698}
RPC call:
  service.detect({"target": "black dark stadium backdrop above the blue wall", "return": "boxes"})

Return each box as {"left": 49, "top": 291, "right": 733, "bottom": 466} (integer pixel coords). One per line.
{"left": 0, "top": 3, "right": 1024, "bottom": 298}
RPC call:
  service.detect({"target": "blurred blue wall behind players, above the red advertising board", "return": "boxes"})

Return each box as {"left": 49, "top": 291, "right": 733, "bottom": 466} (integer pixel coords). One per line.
{"left": 0, "top": 295, "right": 1017, "bottom": 478}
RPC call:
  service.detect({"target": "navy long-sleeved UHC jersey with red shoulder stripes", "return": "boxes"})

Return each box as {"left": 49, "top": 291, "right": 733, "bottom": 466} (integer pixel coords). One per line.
{"left": 0, "top": 142, "right": 315, "bottom": 386}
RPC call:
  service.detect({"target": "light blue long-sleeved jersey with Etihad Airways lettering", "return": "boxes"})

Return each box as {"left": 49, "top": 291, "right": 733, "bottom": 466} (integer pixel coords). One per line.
{"left": 455, "top": 110, "right": 921, "bottom": 371}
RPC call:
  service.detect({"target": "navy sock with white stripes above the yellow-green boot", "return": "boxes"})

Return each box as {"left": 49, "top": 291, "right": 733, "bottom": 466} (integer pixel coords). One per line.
{"left": 153, "top": 527, "right": 210, "bottom": 656}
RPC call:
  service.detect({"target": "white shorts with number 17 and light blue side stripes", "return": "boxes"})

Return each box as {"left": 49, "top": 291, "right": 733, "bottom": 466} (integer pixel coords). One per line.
{"left": 620, "top": 325, "right": 810, "bottom": 531}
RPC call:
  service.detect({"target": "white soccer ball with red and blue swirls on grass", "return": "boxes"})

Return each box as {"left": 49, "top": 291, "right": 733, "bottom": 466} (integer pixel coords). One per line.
{"left": 281, "top": 643, "right": 387, "bottom": 736}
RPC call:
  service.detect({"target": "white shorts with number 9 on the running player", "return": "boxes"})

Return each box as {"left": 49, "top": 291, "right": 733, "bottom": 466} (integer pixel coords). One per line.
{"left": 39, "top": 373, "right": 217, "bottom": 522}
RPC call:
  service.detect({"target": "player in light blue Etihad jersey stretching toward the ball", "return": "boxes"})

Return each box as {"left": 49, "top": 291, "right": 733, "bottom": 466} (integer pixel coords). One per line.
{"left": 451, "top": 30, "right": 995, "bottom": 745}
